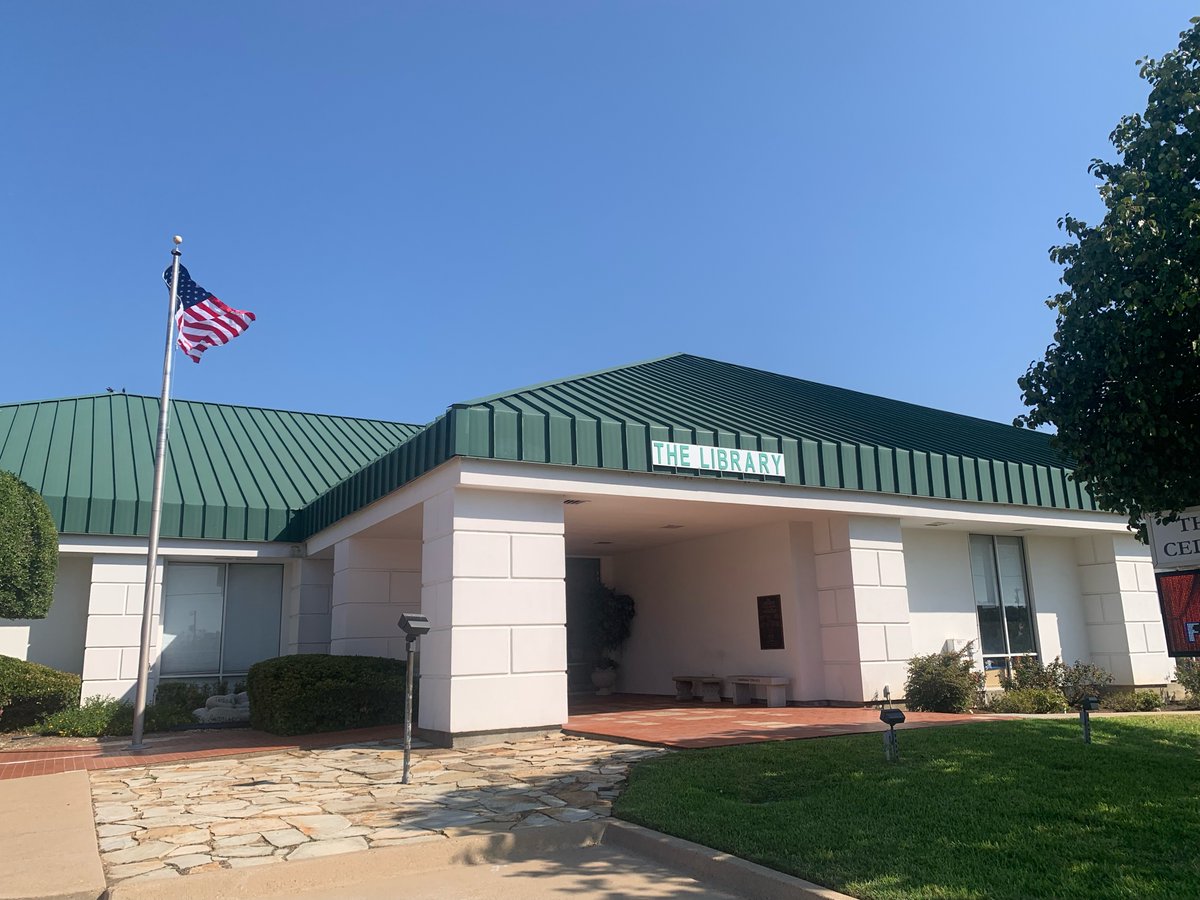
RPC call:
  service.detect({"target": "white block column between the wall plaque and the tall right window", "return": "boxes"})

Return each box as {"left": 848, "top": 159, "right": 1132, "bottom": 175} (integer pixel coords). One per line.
{"left": 812, "top": 516, "right": 912, "bottom": 703}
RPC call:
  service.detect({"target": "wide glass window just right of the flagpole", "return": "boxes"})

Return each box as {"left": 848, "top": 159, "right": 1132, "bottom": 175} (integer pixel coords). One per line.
{"left": 158, "top": 563, "right": 283, "bottom": 678}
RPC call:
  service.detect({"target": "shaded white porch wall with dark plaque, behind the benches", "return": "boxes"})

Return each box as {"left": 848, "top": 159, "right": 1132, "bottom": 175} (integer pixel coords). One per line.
{"left": 606, "top": 523, "right": 824, "bottom": 700}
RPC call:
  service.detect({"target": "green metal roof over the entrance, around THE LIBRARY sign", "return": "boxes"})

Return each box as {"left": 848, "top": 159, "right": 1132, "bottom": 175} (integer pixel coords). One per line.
{"left": 294, "top": 354, "right": 1097, "bottom": 540}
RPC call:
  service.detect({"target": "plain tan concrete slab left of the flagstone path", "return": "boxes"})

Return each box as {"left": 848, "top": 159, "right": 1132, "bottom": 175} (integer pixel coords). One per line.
{"left": 0, "top": 772, "right": 106, "bottom": 900}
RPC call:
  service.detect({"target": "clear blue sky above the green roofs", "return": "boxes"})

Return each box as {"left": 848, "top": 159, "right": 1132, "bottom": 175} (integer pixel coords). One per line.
{"left": 0, "top": 0, "right": 1193, "bottom": 422}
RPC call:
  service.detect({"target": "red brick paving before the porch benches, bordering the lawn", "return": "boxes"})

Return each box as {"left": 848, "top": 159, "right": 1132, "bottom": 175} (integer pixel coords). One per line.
{"left": 563, "top": 694, "right": 1009, "bottom": 748}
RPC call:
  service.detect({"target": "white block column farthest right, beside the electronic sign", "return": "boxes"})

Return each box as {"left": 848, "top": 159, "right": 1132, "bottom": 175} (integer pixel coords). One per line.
{"left": 1067, "top": 534, "right": 1175, "bottom": 685}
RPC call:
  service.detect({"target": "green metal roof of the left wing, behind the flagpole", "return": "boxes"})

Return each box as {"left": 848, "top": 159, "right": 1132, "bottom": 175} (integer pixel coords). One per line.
{"left": 0, "top": 394, "right": 421, "bottom": 540}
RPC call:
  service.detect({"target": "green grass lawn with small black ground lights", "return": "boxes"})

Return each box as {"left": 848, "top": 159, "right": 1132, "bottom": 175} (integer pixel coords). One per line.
{"left": 614, "top": 715, "right": 1200, "bottom": 899}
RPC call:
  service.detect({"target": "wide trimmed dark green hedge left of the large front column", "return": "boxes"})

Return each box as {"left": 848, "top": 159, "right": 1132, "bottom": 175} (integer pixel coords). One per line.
{"left": 246, "top": 653, "right": 404, "bottom": 734}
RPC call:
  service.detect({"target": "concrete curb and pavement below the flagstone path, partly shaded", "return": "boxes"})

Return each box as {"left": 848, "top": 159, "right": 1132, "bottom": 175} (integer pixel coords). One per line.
{"left": 108, "top": 820, "right": 851, "bottom": 900}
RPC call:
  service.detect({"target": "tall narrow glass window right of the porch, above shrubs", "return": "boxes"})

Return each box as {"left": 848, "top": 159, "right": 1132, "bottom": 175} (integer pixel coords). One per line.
{"left": 971, "top": 534, "right": 1037, "bottom": 677}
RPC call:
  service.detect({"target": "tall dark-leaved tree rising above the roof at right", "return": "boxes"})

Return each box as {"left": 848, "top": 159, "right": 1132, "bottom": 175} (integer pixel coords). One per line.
{"left": 1014, "top": 19, "right": 1200, "bottom": 526}
